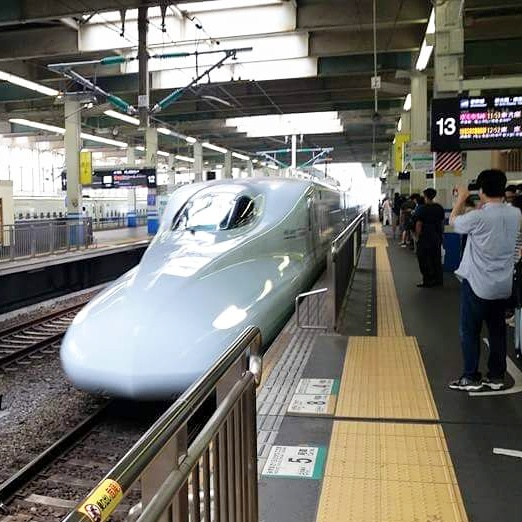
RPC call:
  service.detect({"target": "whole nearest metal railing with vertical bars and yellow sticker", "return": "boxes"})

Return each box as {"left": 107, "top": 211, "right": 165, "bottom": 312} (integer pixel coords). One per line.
{"left": 64, "top": 327, "right": 262, "bottom": 522}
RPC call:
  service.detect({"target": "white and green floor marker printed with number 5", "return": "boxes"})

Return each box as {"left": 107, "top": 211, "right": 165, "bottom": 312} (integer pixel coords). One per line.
{"left": 262, "top": 446, "right": 326, "bottom": 479}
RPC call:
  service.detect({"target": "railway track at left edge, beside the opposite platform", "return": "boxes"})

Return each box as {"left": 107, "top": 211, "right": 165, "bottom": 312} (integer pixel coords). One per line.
{"left": 0, "top": 303, "right": 85, "bottom": 371}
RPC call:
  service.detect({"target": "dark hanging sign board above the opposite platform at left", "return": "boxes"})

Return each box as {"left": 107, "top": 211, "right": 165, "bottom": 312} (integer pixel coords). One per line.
{"left": 62, "top": 167, "right": 157, "bottom": 190}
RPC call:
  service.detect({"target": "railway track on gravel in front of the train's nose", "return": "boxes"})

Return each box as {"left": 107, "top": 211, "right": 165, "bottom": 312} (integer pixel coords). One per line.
{"left": 0, "top": 401, "right": 166, "bottom": 522}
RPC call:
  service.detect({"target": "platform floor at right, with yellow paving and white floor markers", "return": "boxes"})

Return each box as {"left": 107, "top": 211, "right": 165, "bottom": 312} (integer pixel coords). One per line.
{"left": 258, "top": 223, "right": 522, "bottom": 522}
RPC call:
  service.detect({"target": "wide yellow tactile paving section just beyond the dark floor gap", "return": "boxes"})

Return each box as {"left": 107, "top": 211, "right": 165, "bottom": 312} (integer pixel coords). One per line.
{"left": 336, "top": 337, "right": 438, "bottom": 420}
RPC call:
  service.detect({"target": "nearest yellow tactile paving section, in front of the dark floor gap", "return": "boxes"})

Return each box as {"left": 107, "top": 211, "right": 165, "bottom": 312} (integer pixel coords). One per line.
{"left": 317, "top": 421, "right": 468, "bottom": 522}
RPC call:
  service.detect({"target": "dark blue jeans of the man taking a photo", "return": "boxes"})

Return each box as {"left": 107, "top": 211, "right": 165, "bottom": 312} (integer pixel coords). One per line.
{"left": 459, "top": 279, "right": 506, "bottom": 379}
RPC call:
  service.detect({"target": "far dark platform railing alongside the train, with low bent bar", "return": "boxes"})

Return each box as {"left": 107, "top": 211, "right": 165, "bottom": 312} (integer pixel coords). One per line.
{"left": 295, "top": 209, "right": 369, "bottom": 331}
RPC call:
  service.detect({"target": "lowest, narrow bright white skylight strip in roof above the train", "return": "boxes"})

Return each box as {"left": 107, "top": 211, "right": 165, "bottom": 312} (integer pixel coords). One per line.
{"left": 226, "top": 111, "right": 344, "bottom": 138}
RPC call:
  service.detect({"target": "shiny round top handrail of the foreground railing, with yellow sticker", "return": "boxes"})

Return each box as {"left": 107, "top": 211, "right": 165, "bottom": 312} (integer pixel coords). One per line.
{"left": 64, "top": 326, "right": 262, "bottom": 522}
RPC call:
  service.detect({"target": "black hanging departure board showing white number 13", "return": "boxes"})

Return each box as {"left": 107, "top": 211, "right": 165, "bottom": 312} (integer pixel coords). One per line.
{"left": 431, "top": 96, "right": 522, "bottom": 152}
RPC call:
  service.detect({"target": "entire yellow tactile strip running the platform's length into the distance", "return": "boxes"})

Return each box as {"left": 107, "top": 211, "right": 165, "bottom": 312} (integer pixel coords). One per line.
{"left": 316, "top": 221, "right": 468, "bottom": 522}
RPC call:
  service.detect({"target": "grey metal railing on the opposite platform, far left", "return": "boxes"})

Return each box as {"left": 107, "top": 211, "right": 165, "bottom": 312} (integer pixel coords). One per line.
{"left": 0, "top": 220, "right": 93, "bottom": 261}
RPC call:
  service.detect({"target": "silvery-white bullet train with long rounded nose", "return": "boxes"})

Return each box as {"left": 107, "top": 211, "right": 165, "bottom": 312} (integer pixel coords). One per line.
{"left": 60, "top": 178, "right": 347, "bottom": 400}
